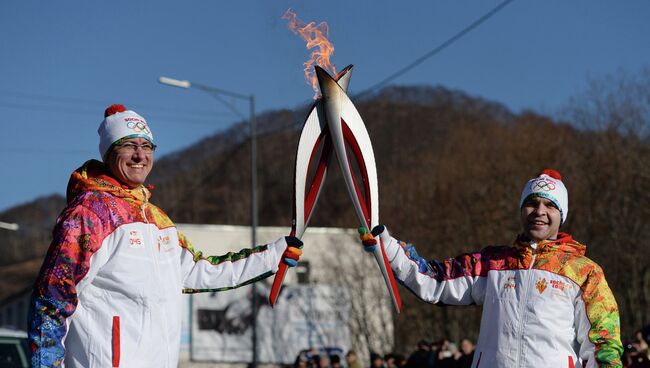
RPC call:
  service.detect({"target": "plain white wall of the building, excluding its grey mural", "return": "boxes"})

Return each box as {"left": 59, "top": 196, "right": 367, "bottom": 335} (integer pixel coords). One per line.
{"left": 178, "top": 224, "right": 393, "bottom": 367}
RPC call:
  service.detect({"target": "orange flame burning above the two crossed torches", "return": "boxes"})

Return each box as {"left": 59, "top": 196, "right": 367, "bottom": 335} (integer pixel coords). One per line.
{"left": 282, "top": 9, "right": 336, "bottom": 99}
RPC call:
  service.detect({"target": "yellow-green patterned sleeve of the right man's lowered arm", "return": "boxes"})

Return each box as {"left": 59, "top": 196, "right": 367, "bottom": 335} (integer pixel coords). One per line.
{"left": 576, "top": 266, "right": 623, "bottom": 368}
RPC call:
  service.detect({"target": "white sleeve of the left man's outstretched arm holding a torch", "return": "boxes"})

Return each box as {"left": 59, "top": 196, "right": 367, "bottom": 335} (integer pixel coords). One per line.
{"left": 178, "top": 232, "right": 287, "bottom": 293}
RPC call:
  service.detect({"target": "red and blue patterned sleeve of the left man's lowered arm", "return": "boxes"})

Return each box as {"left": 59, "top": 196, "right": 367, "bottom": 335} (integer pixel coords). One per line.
{"left": 28, "top": 206, "right": 101, "bottom": 367}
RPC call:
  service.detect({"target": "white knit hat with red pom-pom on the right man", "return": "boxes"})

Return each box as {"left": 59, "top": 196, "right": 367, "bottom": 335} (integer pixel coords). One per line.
{"left": 519, "top": 169, "right": 569, "bottom": 223}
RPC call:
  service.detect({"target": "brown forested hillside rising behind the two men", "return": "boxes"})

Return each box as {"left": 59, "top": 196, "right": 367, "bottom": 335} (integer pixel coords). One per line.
{"left": 1, "top": 72, "right": 650, "bottom": 350}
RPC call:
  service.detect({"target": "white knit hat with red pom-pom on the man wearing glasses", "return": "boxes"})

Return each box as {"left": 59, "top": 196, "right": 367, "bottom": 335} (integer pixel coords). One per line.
{"left": 97, "top": 104, "right": 153, "bottom": 158}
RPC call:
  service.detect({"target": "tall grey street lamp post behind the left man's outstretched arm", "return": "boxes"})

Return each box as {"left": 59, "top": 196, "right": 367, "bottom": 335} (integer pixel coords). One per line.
{"left": 158, "top": 77, "right": 258, "bottom": 368}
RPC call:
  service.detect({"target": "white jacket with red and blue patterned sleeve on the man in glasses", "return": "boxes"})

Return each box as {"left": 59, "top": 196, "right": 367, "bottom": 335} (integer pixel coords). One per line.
{"left": 29, "top": 160, "right": 287, "bottom": 368}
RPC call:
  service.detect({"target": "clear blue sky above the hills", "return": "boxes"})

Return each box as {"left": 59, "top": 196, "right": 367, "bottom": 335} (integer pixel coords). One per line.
{"left": 0, "top": 0, "right": 650, "bottom": 211}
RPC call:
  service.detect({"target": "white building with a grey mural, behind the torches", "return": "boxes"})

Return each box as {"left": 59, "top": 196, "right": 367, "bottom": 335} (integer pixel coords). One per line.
{"left": 178, "top": 224, "right": 393, "bottom": 367}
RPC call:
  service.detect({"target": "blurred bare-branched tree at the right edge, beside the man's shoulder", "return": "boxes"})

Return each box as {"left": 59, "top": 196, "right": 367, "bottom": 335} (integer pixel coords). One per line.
{"left": 563, "top": 68, "right": 650, "bottom": 336}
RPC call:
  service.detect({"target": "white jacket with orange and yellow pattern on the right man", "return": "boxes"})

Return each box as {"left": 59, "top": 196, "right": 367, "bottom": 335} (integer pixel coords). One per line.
{"left": 380, "top": 227, "right": 623, "bottom": 368}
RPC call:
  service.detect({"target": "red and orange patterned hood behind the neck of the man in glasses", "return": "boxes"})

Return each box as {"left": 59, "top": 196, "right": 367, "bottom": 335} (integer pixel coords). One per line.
{"left": 66, "top": 160, "right": 151, "bottom": 204}
